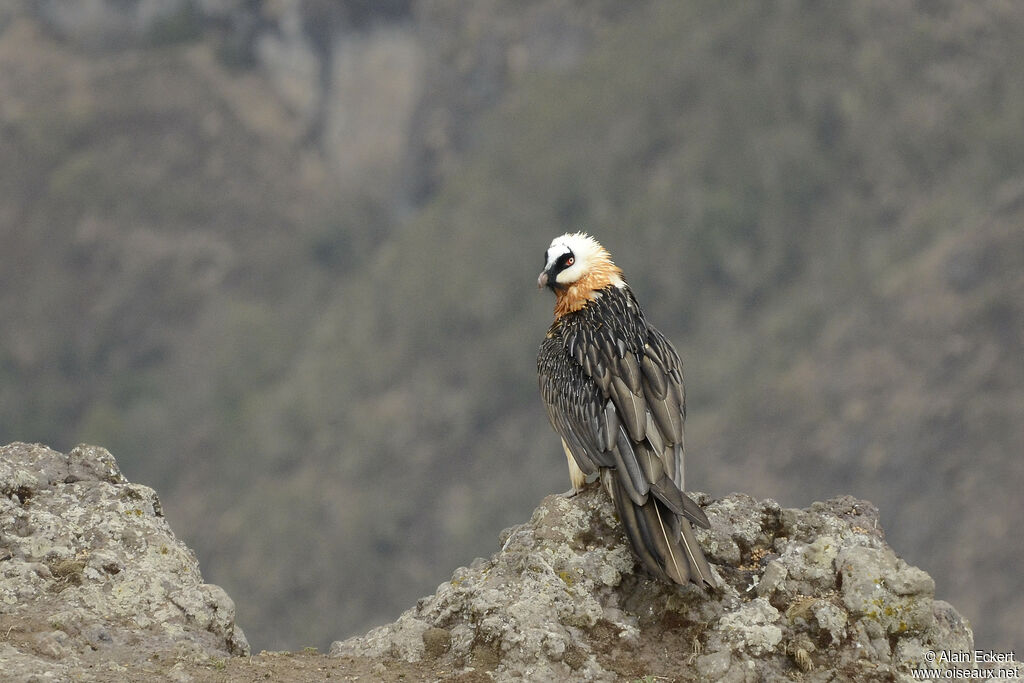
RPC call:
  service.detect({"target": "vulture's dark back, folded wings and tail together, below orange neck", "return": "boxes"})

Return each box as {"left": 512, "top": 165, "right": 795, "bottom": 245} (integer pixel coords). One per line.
{"left": 541, "top": 286, "right": 715, "bottom": 587}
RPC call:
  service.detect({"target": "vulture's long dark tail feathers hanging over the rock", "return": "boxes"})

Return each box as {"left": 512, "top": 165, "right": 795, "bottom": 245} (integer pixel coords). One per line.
{"left": 601, "top": 469, "right": 718, "bottom": 589}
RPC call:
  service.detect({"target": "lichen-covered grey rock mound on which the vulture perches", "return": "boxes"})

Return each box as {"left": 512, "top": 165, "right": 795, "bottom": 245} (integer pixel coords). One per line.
{"left": 331, "top": 489, "right": 1007, "bottom": 681}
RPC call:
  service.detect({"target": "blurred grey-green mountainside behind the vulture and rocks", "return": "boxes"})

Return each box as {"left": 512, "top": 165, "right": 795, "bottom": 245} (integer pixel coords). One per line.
{"left": 0, "top": 0, "right": 1024, "bottom": 650}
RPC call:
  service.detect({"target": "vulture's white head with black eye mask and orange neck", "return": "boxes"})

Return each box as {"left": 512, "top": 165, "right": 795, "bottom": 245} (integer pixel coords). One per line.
{"left": 537, "top": 232, "right": 626, "bottom": 314}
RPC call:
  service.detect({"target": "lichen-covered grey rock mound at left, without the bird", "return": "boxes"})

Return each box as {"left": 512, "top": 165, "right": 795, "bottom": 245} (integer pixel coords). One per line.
{"left": 0, "top": 443, "right": 249, "bottom": 681}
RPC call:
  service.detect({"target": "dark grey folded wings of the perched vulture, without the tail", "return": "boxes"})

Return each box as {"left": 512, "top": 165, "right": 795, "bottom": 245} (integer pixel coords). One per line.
{"left": 538, "top": 313, "right": 710, "bottom": 527}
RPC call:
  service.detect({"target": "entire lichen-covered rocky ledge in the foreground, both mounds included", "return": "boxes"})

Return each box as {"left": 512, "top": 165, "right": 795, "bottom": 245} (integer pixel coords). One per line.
{"left": 0, "top": 443, "right": 1024, "bottom": 682}
